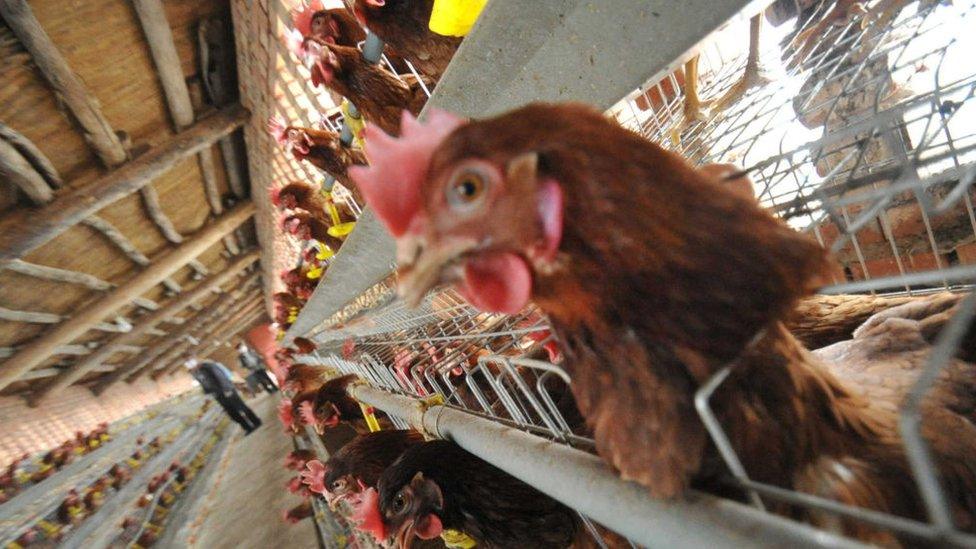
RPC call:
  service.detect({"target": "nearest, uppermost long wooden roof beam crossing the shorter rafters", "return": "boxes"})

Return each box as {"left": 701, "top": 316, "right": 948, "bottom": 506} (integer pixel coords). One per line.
{"left": 0, "top": 107, "right": 249, "bottom": 259}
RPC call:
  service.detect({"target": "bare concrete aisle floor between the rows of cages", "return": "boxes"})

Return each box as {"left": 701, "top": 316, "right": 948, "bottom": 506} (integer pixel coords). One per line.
{"left": 181, "top": 395, "right": 318, "bottom": 549}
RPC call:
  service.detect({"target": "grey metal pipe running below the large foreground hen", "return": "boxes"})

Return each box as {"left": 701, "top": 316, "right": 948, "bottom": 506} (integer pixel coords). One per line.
{"left": 349, "top": 385, "right": 865, "bottom": 549}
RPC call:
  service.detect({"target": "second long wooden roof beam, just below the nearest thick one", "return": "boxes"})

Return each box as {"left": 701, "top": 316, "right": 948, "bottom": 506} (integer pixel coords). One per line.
{"left": 0, "top": 201, "right": 254, "bottom": 390}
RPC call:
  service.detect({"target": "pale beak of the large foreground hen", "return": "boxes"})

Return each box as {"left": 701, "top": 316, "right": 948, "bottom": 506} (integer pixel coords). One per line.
{"left": 397, "top": 235, "right": 477, "bottom": 308}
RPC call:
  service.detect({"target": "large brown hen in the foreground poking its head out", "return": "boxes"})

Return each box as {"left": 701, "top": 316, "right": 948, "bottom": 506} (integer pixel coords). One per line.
{"left": 351, "top": 104, "right": 976, "bottom": 543}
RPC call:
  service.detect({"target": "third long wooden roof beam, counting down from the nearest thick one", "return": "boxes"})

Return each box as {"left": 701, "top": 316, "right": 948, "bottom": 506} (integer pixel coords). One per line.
{"left": 28, "top": 251, "right": 258, "bottom": 400}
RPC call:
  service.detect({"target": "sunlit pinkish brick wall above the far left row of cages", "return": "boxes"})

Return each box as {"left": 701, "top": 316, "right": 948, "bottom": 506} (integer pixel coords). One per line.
{"left": 0, "top": 374, "right": 196, "bottom": 467}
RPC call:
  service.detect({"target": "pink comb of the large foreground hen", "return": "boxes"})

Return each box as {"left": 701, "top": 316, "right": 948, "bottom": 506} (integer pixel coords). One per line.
{"left": 349, "top": 109, "right": 464, "bottom": 237}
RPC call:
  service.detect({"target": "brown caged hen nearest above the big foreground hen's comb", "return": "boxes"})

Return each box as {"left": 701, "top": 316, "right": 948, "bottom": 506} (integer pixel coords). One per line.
{"left": 312, "top": 44, "right": 432, "bottom": 134}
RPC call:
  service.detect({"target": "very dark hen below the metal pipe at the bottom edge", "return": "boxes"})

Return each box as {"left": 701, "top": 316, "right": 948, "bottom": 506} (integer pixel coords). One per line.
{"left": 351, "top": 440, "right": 589, "bottom": 549}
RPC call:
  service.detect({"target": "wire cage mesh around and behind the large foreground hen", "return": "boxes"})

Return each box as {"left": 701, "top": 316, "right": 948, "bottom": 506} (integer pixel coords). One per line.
{"left": 280, "top": 0, "right": 976, "bottom": 545}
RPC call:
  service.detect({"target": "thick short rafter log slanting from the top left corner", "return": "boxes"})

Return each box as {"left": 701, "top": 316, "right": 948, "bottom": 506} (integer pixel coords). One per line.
{"left": 0, "top": 0, "right": 128, "bottom": 167}
